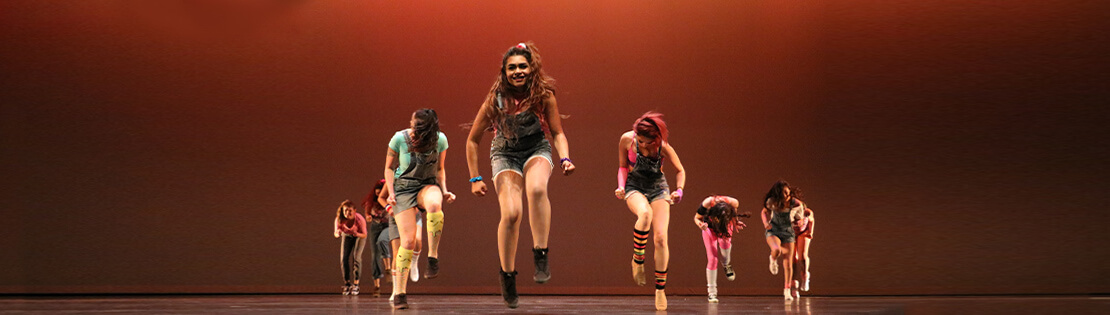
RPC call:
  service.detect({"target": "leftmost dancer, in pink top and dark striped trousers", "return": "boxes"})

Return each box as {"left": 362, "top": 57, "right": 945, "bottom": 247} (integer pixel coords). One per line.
{"left": 333, "top": 200, "right": 366, "bottom": 295}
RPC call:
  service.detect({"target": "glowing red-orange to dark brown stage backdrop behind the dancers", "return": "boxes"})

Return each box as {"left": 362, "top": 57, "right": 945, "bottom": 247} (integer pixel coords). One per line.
{"left": 0, "top": 0, "right": 1110, "bottom": 295}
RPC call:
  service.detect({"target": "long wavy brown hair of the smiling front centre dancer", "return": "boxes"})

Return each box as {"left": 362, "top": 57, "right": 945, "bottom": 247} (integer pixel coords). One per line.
{"left": 483, "top": 41, "right": 555, "bottom": 138}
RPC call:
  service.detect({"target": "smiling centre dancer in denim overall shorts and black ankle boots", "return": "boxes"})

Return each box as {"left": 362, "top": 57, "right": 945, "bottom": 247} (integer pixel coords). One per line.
{"left": 466, "top": 42, "right": 574, "bottom": 308}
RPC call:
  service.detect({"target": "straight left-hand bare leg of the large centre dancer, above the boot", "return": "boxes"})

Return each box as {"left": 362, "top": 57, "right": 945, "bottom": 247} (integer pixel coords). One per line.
{"left": 494, "top": 172, "right": 524, "bottom": 272}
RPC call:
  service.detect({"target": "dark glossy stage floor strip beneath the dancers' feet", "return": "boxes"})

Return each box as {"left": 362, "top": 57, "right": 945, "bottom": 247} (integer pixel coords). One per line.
{"left": 0, "top": 294, "right": 1110, "bottom": 315}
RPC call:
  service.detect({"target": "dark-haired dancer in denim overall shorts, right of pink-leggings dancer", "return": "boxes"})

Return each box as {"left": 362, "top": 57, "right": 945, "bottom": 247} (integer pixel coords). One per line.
{"left": 761, "top": 181, "right": 806, "bottom": 302}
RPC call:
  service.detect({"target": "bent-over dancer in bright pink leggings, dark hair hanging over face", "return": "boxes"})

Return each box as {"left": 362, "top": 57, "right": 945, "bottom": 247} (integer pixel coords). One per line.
{"left": 694, "top": 195, "right": 751, "bottom": 303}
